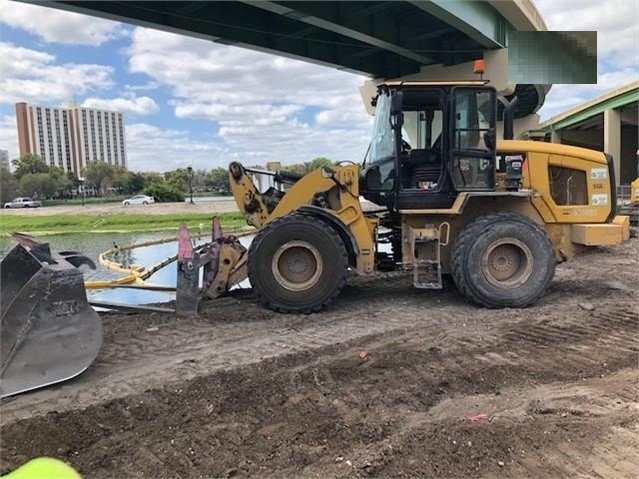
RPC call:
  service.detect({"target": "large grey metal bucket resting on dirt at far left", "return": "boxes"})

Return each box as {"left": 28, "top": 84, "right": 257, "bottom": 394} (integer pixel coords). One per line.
{"left": 0, "top": 233, "right": 102, "bottom": 397}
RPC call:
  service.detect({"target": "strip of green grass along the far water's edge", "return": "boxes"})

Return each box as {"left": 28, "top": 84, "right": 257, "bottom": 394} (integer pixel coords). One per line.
{"left": 0, "top": 212, "right": 247, "bottom": 236}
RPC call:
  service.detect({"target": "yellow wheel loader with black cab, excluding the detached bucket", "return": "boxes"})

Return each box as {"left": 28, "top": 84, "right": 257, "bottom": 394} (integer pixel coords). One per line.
{"left": 222, "top": 81, "right": 629, "bottom": 313}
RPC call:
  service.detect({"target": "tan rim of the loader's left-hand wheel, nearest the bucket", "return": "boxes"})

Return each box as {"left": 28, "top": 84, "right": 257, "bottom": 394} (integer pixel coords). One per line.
{"left": 271, "top": 241, "right": 324, "bottom": 291}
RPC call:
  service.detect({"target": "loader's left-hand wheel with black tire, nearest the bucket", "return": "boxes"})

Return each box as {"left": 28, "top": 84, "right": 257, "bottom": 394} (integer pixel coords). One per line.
{"left": 248, "top": 214, "right": 348, "bottom": 314}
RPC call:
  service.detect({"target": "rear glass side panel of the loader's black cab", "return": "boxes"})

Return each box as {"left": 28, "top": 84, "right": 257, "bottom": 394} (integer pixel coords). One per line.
{"left": 448, "top": 87, "right": 497, "bottom": 191}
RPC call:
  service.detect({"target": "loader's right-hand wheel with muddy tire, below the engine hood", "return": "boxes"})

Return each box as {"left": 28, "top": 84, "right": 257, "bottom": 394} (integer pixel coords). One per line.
{"left": 451, "top": 213, "right": 556, "bottom": 308}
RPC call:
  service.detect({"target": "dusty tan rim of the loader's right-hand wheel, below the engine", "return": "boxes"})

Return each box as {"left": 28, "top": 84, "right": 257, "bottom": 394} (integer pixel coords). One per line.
{"left": 481, "top": 238, "right": 533, "bottom": 289}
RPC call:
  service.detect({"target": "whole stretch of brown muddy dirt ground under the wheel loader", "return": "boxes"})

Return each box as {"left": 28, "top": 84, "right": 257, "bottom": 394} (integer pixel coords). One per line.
{"left": 0, "top": 239, "right": 639, "bottom": 478}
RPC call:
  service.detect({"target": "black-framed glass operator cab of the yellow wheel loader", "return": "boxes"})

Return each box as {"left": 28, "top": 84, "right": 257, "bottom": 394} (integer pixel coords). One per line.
{"left": 361, "top": 83, "right": 497, "bottom": 210}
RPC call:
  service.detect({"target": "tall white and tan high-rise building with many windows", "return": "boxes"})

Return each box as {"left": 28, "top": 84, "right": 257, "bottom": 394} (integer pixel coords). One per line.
{"left": 16, "top": 103, "right": 127, "bottom": 177}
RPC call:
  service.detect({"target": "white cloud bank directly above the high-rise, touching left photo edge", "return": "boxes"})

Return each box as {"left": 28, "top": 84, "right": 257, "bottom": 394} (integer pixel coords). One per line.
{"left": 0, "top": 42, "right": 113, "bottom": 104}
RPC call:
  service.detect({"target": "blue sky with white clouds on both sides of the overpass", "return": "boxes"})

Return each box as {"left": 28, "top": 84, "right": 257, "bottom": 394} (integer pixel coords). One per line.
{"left": 0, "top": 0, "right": 639, "bottom": 171}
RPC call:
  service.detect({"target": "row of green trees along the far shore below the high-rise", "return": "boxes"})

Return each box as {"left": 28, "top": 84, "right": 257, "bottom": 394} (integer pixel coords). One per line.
{"left": 0, "top": 154, "right": 340, "bottom": 203}
